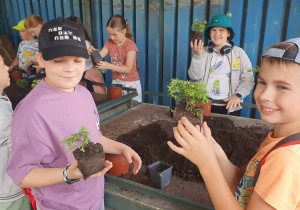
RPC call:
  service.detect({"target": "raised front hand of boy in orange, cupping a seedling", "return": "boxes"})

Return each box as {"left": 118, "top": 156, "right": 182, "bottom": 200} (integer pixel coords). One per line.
{"left": 168, "top": 117, "right": 217, "bottom": 170}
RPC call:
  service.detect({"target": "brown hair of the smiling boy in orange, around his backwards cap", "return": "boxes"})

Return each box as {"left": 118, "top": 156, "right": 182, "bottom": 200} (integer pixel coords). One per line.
{"left": 262, "top": 42, "right": 299, "bottom": 65}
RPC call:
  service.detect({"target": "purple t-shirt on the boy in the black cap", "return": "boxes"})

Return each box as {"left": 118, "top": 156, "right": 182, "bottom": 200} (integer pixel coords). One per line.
{"left": 6, "top": 80, "right": 104, "bottom": 210}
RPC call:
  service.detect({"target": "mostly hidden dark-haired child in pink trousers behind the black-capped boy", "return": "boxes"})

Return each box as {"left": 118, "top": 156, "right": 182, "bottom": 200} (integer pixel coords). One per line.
{"left": 67, "top": 16, "right": 107, "bottom": 94}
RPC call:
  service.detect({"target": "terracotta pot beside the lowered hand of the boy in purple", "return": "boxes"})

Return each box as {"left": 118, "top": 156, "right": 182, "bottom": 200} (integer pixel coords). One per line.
{"left": 105, "top": 153, "right": 129, "bottom": 176}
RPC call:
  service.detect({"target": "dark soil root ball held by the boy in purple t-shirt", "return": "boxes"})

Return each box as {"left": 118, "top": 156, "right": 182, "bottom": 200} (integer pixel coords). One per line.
{"left": 73, "top": 142, "right": 105, "bottom": 180}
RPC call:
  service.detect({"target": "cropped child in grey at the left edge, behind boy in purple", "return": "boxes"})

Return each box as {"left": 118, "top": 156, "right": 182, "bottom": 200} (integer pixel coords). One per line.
{"left": 0, "top": 56, "right": 31, "bottom": 210}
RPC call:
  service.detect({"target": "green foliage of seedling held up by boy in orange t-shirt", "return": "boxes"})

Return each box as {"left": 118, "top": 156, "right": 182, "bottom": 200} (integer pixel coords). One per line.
{"left": 167, "top": 79, "right": 210, "bottom": 114}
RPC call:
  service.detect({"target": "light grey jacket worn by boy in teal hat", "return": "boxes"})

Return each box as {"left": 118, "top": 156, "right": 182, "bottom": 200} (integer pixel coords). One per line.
{"left": 188, "top": 46, "right": 254, "bottom": 111}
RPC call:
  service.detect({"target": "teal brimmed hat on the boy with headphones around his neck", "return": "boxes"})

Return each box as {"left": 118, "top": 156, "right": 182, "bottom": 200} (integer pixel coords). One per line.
{"left": 203, "top": 12, "right": 235, "bottom": 40}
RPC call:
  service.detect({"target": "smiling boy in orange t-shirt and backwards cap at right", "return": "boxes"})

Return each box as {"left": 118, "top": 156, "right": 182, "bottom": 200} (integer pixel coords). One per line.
{"left": 168, "top": 38, "right": 300, "bottom": 210}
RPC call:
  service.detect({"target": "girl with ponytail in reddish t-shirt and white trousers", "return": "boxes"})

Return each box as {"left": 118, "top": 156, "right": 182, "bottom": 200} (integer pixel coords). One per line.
{"left": 89, "top": 15, "right": 142, "bottom": 102}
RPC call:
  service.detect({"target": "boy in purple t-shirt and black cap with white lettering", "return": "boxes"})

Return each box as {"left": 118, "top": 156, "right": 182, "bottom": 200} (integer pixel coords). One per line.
{"left": 7, "top": 18, "right": 141, "bottom": 210}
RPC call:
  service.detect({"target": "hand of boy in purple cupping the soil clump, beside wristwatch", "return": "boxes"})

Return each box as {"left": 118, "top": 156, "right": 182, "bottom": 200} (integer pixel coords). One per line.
{"left": 67, "top": 160, "right": 113, "bottom": 179}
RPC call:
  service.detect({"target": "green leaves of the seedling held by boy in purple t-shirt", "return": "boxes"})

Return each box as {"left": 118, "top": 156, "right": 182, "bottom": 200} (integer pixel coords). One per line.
{"left": 61, "top": 126, "right": 90, "bottom": 153}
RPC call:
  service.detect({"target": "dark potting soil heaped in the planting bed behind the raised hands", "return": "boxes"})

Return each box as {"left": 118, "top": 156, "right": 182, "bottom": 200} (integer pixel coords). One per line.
{"left": 116, "top": 117, "right": 271, "bottom": 181}
